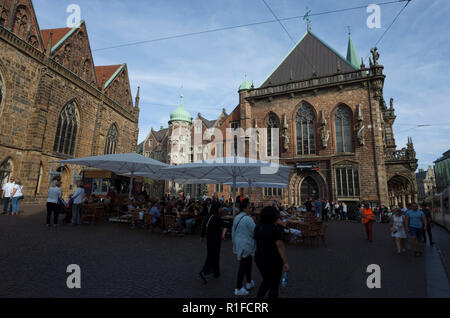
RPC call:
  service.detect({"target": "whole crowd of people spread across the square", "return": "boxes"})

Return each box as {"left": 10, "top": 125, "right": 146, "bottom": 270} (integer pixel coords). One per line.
{"left": 1, "top": 177, "right": 433, "bottom": 298}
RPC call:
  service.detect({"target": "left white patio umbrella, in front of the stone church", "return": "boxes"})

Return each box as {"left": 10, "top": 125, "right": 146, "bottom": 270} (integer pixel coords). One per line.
{"left": 55, "top": 153, "right": 169, "bottom": 196}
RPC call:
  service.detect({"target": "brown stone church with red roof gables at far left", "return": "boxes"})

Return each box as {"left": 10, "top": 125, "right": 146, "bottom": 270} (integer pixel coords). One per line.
{"left": 0, "top": 0, "right": 139, "bottom": 202}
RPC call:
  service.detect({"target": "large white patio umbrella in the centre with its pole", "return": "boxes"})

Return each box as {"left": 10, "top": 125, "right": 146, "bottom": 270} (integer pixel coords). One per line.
{"left": 162, "top": 157, "right": 292, "bottom": 211}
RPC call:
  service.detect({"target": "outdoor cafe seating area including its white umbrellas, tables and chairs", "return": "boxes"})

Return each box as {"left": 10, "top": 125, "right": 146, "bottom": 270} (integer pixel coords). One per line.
{"left": 59, "top": 153, "right": 327, "bottom": 246}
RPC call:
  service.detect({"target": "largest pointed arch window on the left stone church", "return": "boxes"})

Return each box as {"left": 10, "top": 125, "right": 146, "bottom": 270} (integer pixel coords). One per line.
{"left": 53, "top": 101, "right": 78, "bottom": 156}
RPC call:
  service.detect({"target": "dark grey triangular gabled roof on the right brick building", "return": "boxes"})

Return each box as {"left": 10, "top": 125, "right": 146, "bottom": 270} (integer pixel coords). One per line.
{"left": 261, "top": 31, "right": 356, "bottom": 88}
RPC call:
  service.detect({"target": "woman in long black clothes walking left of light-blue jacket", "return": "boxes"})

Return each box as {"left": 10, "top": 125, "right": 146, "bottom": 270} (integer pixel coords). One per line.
{"left": 199, "top": 200, "right": 226, "bottom": 284}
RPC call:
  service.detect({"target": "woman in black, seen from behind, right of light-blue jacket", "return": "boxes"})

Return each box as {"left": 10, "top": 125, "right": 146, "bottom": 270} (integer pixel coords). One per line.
{"left": 254, "top": 206, "right": 289, "bottom": 299}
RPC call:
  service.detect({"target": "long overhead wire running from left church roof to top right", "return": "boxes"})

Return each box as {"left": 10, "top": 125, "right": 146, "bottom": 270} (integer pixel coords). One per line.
{"left": 93, "top": 0, "right": 411, "bottom": 51}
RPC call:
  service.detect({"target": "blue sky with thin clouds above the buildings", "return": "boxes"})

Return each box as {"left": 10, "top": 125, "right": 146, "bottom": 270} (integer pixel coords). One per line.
{"left": 33, "top": 0, "right": 450, "bottom": 168}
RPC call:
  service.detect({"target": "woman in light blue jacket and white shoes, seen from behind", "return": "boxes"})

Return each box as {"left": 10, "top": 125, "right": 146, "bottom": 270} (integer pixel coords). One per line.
{"left": 231, "top": 198, "right": 256, "bottom": 296}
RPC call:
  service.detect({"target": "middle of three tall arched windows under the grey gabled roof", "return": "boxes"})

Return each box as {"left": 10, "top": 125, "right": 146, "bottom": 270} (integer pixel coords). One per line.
{"left": 296, "top": 103, "right": 316, "bottom": 155}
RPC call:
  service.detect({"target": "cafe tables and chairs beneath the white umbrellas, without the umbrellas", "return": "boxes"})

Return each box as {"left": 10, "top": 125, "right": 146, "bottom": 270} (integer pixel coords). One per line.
{"left": 59, "top": 196, "right": 328, "bottom": 247}
